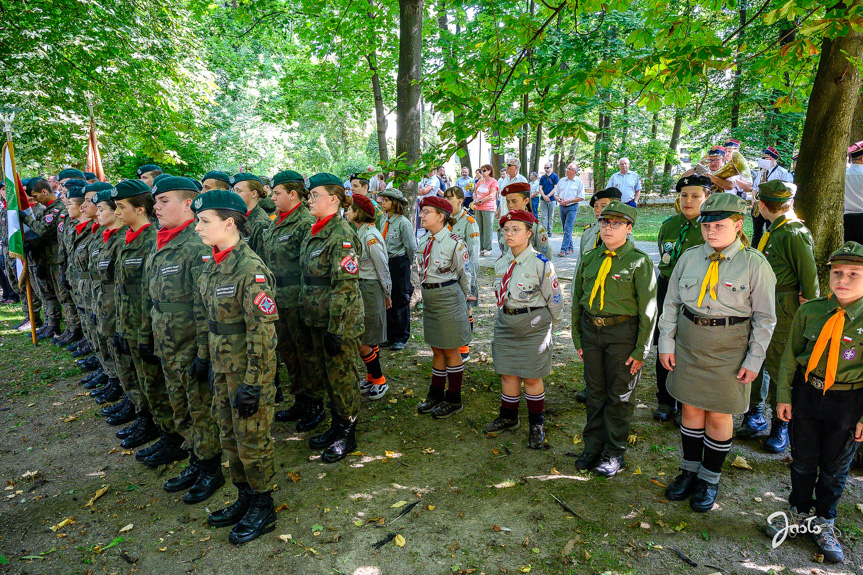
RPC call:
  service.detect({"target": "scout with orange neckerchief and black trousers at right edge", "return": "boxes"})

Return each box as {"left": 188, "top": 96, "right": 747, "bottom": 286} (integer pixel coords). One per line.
{"left": 772, "top": 242, "right": 863, "bottom": 563}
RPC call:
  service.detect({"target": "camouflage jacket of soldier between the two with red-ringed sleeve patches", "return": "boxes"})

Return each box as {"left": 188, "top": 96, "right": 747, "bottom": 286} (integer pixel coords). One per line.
{"left": 261, "top": 204, "right": 315, "bottom": 309}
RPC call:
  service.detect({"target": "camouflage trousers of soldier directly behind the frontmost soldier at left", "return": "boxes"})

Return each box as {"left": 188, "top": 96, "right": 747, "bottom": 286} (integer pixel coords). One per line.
{"left": 162, "top": 341, "right": 222, "bottom": 459}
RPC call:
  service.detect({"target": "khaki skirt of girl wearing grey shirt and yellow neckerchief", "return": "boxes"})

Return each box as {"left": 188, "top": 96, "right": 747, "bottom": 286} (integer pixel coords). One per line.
{"left": 667, "top": 307, "right": 752, "bottom": 414}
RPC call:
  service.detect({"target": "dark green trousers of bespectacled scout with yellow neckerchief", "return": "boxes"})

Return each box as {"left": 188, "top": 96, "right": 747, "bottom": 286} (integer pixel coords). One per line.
{"left": 581, "top": 316, "right": 641, "bottom": 456}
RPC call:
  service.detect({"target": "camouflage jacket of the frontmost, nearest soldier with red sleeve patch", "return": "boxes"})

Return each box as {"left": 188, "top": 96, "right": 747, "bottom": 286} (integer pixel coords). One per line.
{"left": 195, "top": 241, "right": 279, "bottom": 386}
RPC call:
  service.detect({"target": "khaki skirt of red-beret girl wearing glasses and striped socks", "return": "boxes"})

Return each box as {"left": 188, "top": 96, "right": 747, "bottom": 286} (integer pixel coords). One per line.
{"left": 491, "top": 308, "right": 552, "bottom": 379}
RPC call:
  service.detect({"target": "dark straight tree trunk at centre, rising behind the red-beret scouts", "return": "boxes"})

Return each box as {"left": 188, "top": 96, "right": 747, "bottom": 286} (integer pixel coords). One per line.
{"left": 396, "top": 0, "right": 423, "bottom": 206}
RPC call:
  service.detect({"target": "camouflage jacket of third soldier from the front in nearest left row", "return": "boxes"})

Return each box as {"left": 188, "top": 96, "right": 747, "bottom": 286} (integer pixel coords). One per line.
{"left": 114, "top": 224, "right": 156, "bottom": 343}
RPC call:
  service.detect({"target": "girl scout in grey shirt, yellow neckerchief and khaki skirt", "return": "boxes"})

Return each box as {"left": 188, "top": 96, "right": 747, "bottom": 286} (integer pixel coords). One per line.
{"left": 659, "top": 194, "right": 776, "bottom": 513}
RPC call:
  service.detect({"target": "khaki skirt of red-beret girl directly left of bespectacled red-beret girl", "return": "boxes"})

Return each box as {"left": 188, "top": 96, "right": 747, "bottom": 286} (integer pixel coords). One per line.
{"left": 423, "top": 283, "right": 470, "bottom": 349}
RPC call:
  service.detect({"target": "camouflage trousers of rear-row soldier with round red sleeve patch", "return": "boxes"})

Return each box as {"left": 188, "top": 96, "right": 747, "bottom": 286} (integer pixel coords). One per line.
{"left": 309, "top": 327, "right": 360, "bottom": 421}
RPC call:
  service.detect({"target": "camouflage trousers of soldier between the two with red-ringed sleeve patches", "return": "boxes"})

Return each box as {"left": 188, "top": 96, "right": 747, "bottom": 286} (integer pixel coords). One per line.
{"left": 276, "top": 307, "right": 325, "bottom": 401}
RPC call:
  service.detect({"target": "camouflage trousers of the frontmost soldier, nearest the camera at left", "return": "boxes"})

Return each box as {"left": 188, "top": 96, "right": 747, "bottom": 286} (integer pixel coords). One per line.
{"left": 213, "top": 372, "right": 276, "bottom": 492}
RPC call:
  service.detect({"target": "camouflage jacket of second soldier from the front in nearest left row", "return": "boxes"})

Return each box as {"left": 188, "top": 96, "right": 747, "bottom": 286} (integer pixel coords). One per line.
{"left": 141, "top": 221, "right": 212, "bottom": 357}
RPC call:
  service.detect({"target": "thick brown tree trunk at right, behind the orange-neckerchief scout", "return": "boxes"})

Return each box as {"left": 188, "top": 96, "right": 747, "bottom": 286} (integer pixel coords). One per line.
{"left": 794, "top": 31, "right": 863, "bottom": 292}
